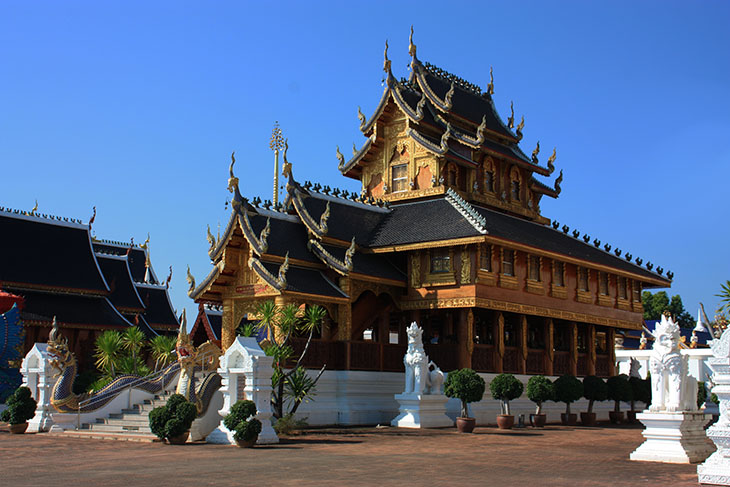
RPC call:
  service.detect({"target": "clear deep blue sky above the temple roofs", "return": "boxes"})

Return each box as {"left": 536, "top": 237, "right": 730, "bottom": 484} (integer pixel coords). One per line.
{"left": 0, "top": 0, "right": 730, "bottom": 324}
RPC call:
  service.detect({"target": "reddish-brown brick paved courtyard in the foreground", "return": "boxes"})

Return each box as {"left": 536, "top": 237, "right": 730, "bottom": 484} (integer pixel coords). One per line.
{"left": 0, "top": 424, "right": 698, "bottom": 487}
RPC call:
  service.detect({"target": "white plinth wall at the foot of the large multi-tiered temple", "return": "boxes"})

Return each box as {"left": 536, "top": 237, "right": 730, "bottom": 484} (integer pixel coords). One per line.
{"left": 296, "top": 370, "right": 628, "bottom": 426}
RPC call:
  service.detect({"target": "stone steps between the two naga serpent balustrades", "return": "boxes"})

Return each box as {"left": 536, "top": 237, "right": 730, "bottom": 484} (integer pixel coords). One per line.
{"left": 52, "top": 392, "right": 172, "bottom": 442}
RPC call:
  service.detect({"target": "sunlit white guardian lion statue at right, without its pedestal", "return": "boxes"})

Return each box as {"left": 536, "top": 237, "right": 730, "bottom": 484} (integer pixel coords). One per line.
{"left": 649, "top": 312, "right": 697, "bottom": 412}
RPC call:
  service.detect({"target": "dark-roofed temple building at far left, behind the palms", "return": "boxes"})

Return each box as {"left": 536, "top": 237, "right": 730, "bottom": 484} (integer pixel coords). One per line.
{"left": 0, "top": 208, "right": 179, "bottom": 370}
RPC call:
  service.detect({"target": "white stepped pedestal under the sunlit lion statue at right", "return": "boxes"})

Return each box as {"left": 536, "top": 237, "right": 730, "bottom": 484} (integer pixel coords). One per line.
{"left": 629, "top": 412, "right": 715, "bottom": 463}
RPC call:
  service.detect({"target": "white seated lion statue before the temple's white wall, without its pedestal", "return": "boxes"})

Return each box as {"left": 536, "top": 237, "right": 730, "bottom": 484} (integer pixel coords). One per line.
{"left": 403, "top": 321, "right": 444, "bottom": 394}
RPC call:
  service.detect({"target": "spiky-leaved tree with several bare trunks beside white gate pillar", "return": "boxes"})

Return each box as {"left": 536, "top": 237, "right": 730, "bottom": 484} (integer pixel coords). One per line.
{"left": 256, "top": 301, "right": 327, "bottom": 419}
